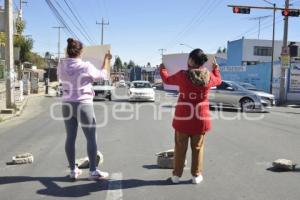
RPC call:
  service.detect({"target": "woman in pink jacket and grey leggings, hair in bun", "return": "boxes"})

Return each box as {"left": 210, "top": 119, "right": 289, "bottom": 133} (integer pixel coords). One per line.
{"left": 57, "top": 38, "right": 111, "bottom": 180}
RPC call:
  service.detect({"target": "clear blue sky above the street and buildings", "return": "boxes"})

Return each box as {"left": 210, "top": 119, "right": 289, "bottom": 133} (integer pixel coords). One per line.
{"left": 0, "top": 0, "right": 300, "bottom": 66}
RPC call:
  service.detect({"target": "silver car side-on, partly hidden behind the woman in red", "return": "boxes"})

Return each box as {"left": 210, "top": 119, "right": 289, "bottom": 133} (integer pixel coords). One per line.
{"left": 209, "top": 81, "right": 275, "bottom": 112}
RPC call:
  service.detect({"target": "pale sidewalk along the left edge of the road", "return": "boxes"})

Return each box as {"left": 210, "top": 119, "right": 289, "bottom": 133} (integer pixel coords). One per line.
{"left": 0, "top": 82, "right": 45, "bottom": 123}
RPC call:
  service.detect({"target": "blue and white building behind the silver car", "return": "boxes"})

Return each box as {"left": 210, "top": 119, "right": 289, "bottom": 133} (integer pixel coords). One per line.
{"left": 225, "top": 38, "right": 300, "bottom": 100}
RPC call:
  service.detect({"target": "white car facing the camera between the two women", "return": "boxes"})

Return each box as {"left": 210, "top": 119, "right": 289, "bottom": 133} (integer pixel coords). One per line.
{"left": 128, "top": 81, "right": 155, "bottom": 102}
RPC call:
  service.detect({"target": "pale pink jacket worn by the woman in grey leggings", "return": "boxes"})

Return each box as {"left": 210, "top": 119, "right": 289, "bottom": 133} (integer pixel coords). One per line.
{"left": 57, "top": 58, "right": 108, "bottom": 103}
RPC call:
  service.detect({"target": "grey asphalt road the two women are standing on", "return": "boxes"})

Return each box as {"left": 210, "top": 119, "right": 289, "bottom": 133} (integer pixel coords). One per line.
{"left": 0, "top": 89, "right": 300, "bottom": 200}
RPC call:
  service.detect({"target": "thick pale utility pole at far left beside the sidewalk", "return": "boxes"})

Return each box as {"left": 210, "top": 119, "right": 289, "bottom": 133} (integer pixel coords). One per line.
{"left": 5, "top": 0, "right": 15, "bottom": 108}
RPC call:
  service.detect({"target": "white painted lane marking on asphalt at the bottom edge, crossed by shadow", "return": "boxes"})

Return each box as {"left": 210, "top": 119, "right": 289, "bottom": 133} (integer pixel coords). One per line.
{"left": 106, "top": 173, "right": 123, "bottom": 200}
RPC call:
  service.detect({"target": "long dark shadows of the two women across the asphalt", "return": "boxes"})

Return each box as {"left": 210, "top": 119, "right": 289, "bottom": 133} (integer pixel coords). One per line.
{"left": 0, "top": 176, "right": 186, "bottom": 197}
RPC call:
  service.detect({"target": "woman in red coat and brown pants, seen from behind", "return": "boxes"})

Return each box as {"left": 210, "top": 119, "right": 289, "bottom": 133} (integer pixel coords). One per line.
{"left": 160, "top": 49, "right": 222, "bottom": 184}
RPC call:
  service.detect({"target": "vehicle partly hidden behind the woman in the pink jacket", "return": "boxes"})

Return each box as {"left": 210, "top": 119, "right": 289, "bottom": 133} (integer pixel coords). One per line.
{"left": 93, "top": 80, "right": 114, "bottom": 101}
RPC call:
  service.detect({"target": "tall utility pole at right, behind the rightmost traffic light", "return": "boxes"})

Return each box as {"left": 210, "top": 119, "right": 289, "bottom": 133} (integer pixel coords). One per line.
{"left": 279, "top": 0, "right": 290, "bottom": 105}
